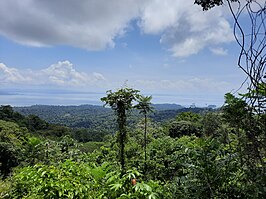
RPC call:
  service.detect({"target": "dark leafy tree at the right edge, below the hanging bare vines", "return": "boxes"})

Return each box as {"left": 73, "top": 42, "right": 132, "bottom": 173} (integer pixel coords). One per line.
{"left": 223, "top": 93, "right": 265, "bottom": 165}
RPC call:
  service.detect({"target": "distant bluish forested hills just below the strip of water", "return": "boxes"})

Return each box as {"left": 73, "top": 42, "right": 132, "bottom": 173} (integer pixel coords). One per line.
{"left": 14, "top": 104, "right": 210, "bottom": 129}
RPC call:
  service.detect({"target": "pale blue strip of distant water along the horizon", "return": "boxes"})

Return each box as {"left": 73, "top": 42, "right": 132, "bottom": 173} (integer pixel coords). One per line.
{"left": 0, "top": 90, "right": 223, "bottom": 107}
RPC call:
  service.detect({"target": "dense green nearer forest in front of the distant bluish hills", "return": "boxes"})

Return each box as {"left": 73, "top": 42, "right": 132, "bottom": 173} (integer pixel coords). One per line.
{"left": 0, "top": 89, "right": 266, "bottom": 199}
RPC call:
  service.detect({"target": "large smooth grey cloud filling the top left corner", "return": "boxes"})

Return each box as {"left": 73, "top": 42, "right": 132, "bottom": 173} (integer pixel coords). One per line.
{"left": 0, "top": 0, "right": 142, "bottom": 50}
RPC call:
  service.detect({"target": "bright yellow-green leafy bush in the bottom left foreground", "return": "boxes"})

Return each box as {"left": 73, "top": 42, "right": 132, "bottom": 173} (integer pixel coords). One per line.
{"left": 10, "top": 160, "right": 95, "bottom": 199}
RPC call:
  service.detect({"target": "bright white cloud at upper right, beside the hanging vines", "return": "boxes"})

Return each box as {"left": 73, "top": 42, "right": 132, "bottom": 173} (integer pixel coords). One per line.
{"left": 155, "top": 1, "right": 234, "bottom": 57}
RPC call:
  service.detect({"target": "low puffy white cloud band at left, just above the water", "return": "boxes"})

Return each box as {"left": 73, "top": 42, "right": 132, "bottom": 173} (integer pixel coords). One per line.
{"left": 0, "top": 61, "right": 107, "bottom": 87}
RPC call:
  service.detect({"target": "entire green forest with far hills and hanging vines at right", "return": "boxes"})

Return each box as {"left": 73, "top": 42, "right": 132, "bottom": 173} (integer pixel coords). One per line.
{"left": 0, "top": 0, "right": 266, "bottom": 199}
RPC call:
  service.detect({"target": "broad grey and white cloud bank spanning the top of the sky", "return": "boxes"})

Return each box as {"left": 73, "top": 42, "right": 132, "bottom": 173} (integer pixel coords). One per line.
{"left": 0, "top": 0, "right": 233, "bottom": 57}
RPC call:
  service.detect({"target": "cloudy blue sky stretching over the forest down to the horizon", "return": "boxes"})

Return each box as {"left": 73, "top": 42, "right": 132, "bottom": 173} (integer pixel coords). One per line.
{"left": 0, "top": 0, "right": 247, "bottom": 105}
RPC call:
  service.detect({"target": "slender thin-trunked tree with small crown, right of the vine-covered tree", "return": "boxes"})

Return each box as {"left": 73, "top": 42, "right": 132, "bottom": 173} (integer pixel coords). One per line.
{"left": 135, "top": 95, "right": 153, "bottom": 175}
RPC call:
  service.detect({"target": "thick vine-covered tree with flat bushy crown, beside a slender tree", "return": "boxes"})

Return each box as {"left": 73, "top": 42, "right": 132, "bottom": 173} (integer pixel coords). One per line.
{"left": 101, "top": 88, "right": 139, "bottom": 176}
